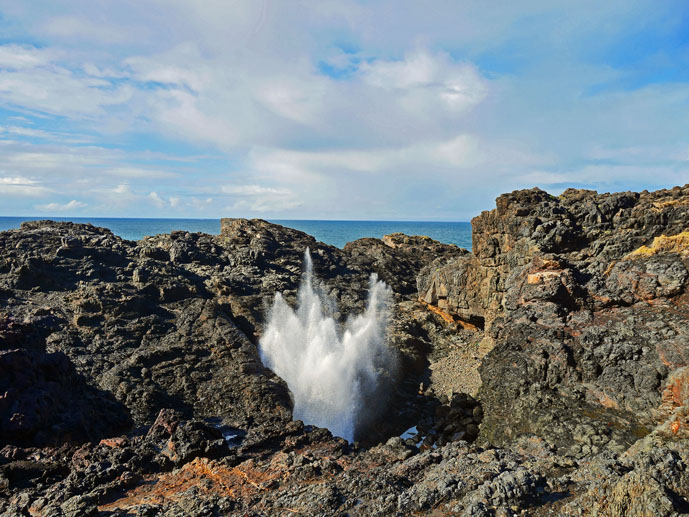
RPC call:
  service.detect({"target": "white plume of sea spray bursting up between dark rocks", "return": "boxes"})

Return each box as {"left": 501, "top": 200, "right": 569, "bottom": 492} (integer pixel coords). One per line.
{"left": 259, "top": 248, "right": 392, "bottom": 441}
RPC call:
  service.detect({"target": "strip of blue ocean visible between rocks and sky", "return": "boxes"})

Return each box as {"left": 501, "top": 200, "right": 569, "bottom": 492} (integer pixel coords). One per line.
{"left": 0, "top": 217, "right": 471, "bottom": 249}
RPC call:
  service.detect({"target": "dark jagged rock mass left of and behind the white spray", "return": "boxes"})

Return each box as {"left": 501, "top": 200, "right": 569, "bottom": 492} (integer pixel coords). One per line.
{"left": 0, "top": 219, "right": 458, "bottom": 444}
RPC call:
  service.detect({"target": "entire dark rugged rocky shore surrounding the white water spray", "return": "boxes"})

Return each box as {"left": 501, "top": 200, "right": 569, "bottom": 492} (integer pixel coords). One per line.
{"left": 0, "top": 185, "right": 689, "bottom": 516}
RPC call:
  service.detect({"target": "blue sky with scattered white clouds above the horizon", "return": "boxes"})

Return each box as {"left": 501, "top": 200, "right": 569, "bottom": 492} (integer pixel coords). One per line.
{"left": 0, "top": 0, "right": 689, "bottom": 221}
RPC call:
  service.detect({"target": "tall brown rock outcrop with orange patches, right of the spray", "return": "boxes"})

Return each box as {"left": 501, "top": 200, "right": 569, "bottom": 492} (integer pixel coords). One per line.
{"left": 419, "top": 183, "right": 689, "bottom": 457}
